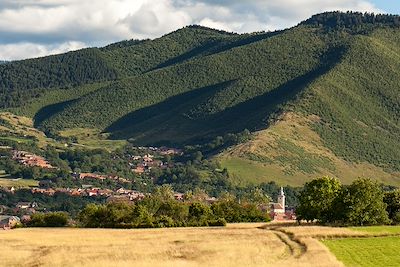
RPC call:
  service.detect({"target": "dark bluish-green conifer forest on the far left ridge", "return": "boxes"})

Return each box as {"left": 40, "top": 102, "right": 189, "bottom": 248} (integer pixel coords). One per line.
{"left": 0, "top": 48, "right": 117, "bottom": 108}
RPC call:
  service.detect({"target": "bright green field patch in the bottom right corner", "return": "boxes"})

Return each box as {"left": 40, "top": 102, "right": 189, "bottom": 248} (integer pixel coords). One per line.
{"left": 323, "top": 239, "right": 400, "bottom": 267}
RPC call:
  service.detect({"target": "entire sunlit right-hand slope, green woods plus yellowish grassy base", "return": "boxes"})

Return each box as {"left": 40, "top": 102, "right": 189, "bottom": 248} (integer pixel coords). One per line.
{"left": 220, "top": 24, "right": 400, "bottom": 184}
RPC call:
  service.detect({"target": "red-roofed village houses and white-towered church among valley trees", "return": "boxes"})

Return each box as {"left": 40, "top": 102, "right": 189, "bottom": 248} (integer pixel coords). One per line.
{"left": 0, "top": 147, "right": 296, "bottom": 229}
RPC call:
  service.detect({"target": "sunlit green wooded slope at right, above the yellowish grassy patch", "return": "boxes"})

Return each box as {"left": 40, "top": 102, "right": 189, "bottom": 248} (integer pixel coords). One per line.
{"left": 296, "top": 30, "right": 400, "bottom": 170}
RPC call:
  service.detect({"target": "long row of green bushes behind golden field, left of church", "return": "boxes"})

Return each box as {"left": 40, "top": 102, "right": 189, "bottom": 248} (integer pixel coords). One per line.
{"left": 78, "top": 187, "right": 270, "bottom": 228}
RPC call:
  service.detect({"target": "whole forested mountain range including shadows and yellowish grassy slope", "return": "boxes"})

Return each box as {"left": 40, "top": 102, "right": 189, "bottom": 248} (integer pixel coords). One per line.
{"left": 0, "top": 12, "right": 400, "bottom": 184}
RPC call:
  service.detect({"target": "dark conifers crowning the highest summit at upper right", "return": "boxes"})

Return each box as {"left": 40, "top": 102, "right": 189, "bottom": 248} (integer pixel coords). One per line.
{"left": 302, "top": 11, "right": 400, "bottom": 29}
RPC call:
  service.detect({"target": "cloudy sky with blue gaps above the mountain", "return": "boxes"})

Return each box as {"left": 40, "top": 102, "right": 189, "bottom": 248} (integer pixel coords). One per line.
{"left": 0, "top": 0, "right": 400, "bottom": 60}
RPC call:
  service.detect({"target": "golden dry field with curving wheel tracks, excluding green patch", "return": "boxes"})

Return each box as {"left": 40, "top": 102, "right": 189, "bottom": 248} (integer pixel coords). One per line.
{"left": 0, "top": 224, "right": 350, "bottom": 267}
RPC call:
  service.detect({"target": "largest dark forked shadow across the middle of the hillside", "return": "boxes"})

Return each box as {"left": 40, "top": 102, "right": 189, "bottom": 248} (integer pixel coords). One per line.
{"left": 105, "top": 48, "right": 343, "bottom": 145}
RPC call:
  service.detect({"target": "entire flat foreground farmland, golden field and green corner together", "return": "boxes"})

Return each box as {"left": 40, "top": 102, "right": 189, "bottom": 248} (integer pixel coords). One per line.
{"left": 0, "top": 224, "right": 400, "bottom": 267}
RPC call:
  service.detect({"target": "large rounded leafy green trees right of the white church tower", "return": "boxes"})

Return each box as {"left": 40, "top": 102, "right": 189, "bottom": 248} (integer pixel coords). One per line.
{"left": 296, "top": 177, "right": 400, "bottom": 226}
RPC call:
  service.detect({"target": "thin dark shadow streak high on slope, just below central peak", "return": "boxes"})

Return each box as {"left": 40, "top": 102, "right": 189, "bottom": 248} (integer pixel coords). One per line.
{"left": 149, "top": 30, "right": 283, "bottom": 72}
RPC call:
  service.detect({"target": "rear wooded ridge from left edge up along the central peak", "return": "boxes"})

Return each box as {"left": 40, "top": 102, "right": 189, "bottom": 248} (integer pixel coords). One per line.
{"left": 0, "top": 27, "right": 236, "bottom": 108}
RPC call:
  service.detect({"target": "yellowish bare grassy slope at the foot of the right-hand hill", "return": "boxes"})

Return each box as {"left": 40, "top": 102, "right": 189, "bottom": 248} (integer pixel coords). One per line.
{"left": 216, "top": 112, "right": 400, "bottom": 186}
